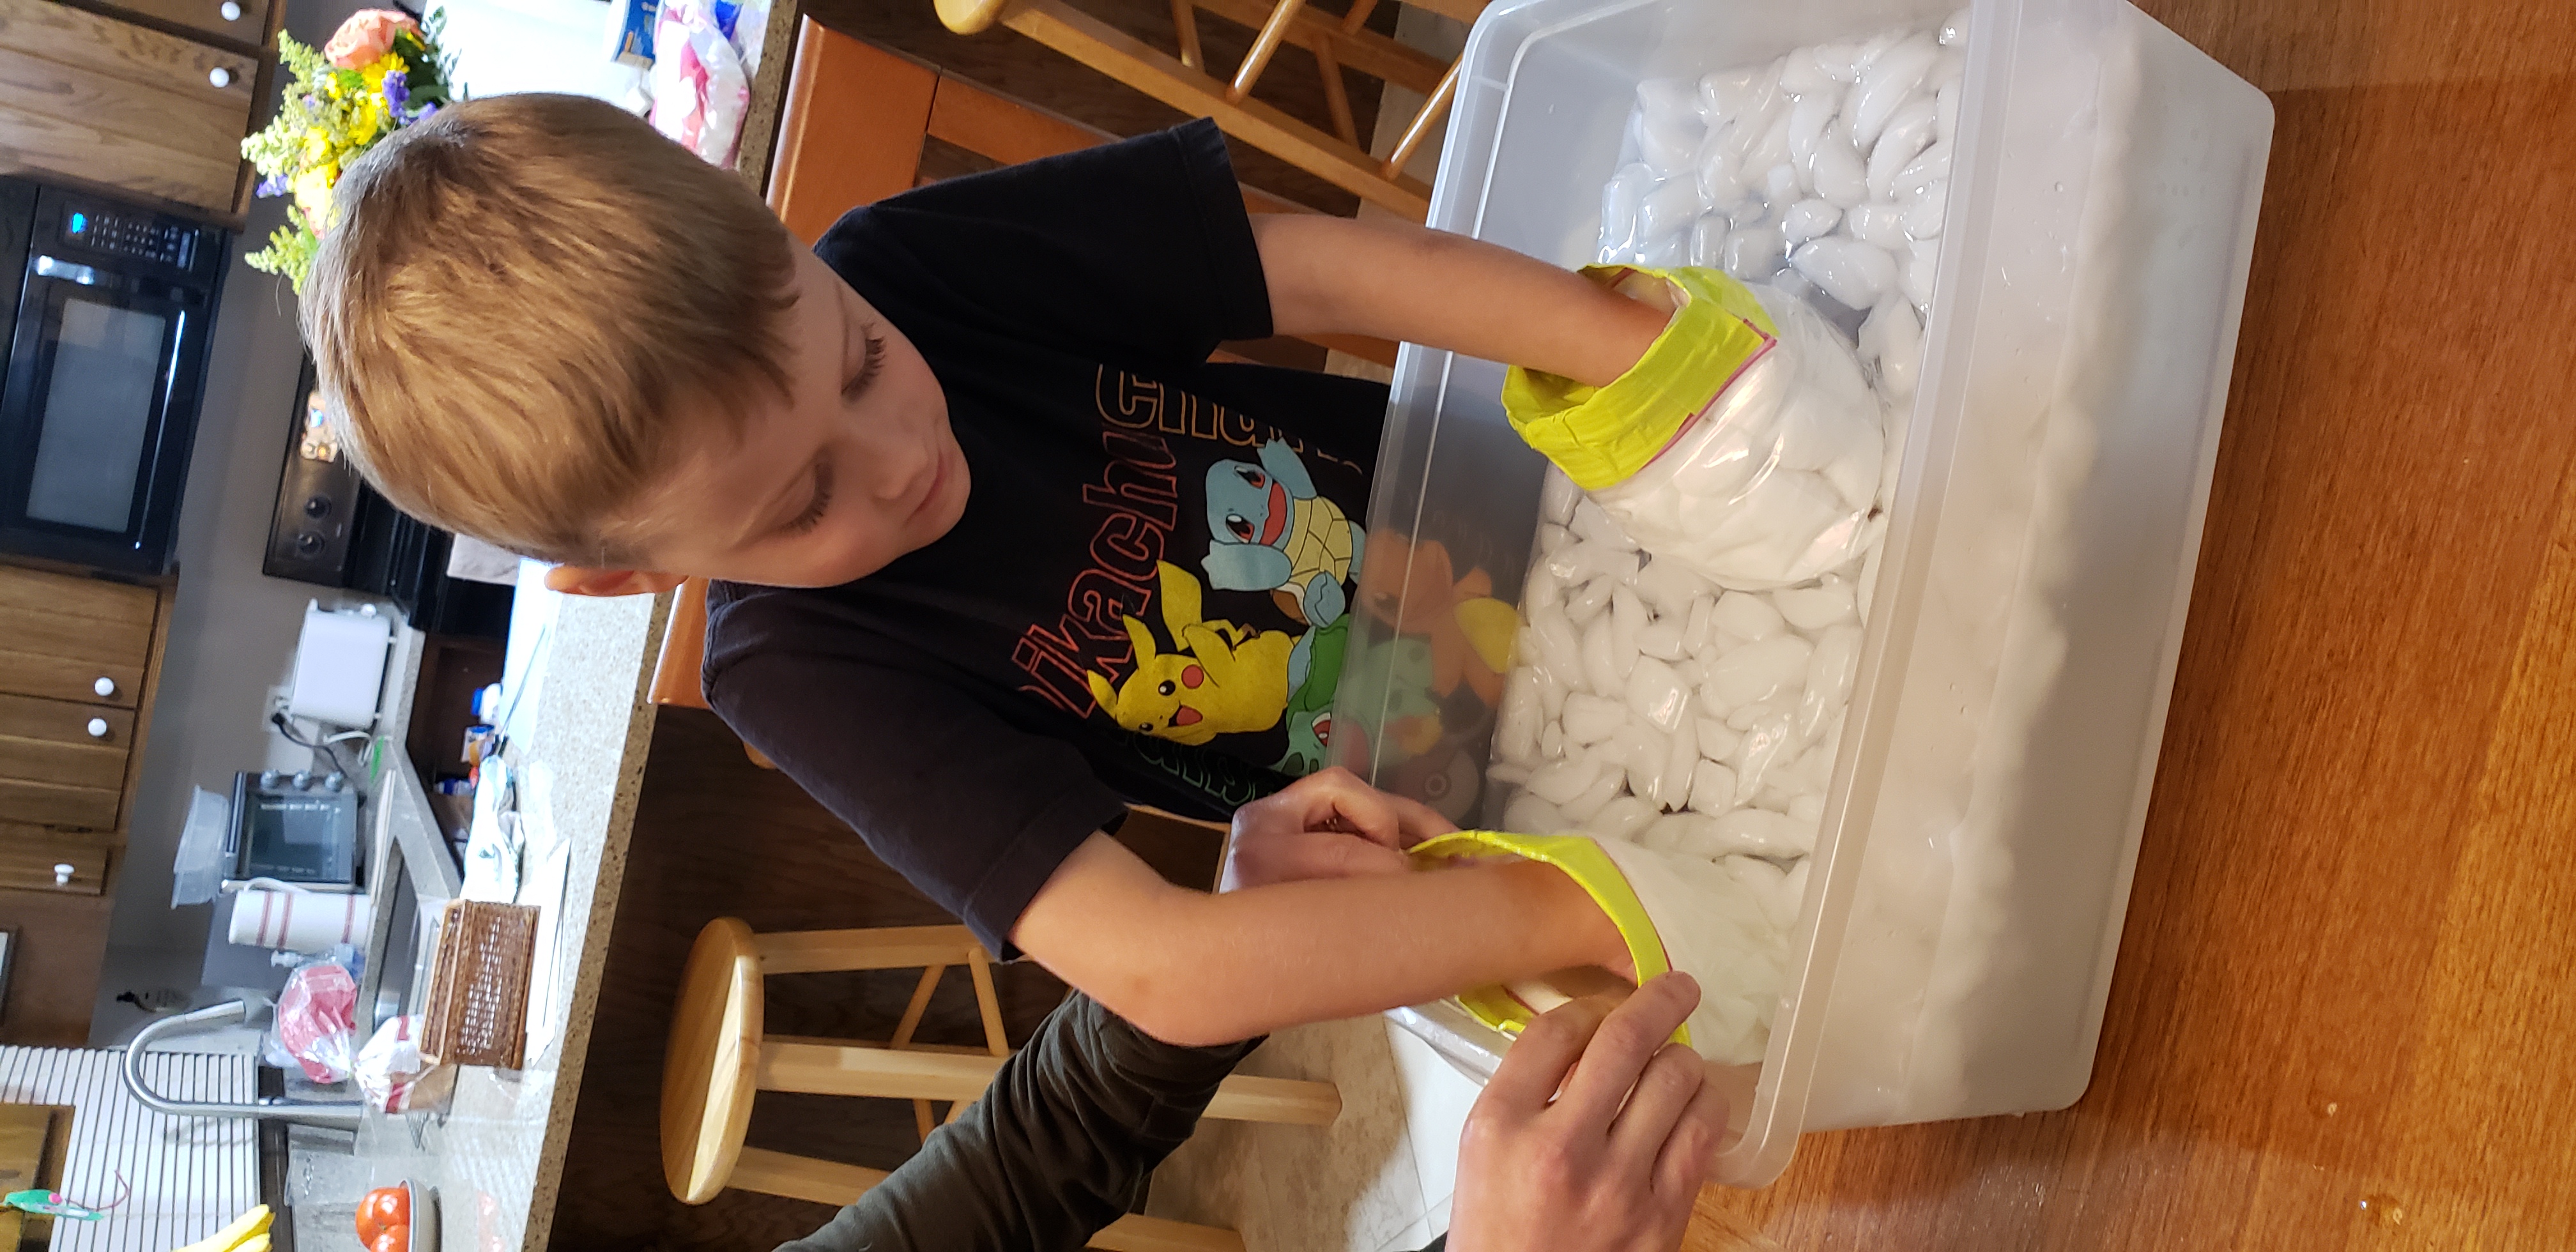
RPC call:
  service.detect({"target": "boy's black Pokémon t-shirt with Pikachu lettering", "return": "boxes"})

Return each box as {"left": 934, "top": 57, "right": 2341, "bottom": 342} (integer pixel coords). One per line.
{"left": 706, "top": 121, "right": 1386, "bottom": 953}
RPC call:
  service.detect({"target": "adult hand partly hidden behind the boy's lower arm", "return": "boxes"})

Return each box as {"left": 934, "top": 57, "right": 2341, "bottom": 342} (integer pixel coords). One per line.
{"left": 1218, "top": 765, "right": 1458, "bottom": 891}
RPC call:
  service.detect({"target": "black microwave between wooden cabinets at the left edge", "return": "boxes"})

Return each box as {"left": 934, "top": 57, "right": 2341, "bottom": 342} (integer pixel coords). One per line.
{"left": 0, "top": 178, "right": 229, "bottom": 574}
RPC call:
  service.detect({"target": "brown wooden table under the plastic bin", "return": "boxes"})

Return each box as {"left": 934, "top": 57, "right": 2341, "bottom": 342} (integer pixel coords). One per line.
{"left": 1687, "top": 0, "right": 2576, "bottom": 1252}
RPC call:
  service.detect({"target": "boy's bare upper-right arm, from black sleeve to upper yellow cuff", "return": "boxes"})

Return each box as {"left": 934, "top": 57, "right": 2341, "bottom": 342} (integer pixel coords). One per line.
{"left": 1252, "top": 214, "right": 1667, "bottom": 386}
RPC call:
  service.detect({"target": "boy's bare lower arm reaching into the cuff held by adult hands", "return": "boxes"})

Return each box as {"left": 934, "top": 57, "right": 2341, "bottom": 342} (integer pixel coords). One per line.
{"left": 1010, "top": 835, "right": 1628, "bottom": 1046}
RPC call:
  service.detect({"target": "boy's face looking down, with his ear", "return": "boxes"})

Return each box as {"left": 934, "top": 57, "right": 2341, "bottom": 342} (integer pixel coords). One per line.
{"left": 546, "top": 247, "right": 969, "bottom": 595}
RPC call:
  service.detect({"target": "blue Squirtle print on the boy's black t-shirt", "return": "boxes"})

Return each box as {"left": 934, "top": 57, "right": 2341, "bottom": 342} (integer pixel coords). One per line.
{"left": 1200, "top": 441, "right": 1365, "bottom": 626}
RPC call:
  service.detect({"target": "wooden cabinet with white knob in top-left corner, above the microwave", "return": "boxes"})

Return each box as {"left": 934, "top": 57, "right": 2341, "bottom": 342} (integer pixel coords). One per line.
{"left": 0, "top": 0, "right": 284, "bottom": 222}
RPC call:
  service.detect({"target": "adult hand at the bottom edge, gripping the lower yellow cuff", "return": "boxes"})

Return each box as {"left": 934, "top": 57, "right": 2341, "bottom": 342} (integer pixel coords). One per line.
{"left": 1448, "top": 973, "right": 1726, "bottom": 1252}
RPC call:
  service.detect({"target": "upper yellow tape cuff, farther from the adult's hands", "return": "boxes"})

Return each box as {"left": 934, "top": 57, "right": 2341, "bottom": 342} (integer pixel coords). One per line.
{"left": 1502, "top": 265, "right": 1780, "bottom": 492}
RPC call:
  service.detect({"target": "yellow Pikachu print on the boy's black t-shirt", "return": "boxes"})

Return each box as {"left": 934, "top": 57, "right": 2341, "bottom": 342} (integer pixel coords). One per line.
{"left": 1084, "top": 561, "right": 1303, "bottom": 745}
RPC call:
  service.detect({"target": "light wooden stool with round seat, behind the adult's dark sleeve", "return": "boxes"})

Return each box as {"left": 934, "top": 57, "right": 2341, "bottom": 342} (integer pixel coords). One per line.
{"left": 662, "top": 917, "right": 1342, "bottom": 1252}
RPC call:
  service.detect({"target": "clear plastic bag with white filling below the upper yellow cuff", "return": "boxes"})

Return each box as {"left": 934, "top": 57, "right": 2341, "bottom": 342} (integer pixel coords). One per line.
{"left": 1592, "top": 286, "right": 1888, "bottom": 590}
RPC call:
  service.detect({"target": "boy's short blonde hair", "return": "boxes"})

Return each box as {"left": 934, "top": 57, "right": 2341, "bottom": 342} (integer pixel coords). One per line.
{"left": 304, "top": 95, "right": 796, "bottom": 564}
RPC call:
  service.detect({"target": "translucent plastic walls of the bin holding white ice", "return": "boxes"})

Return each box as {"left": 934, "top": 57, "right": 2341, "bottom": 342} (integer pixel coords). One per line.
{"left": 1335, "top": 0, "right": 2272, "bottom": 1185}
